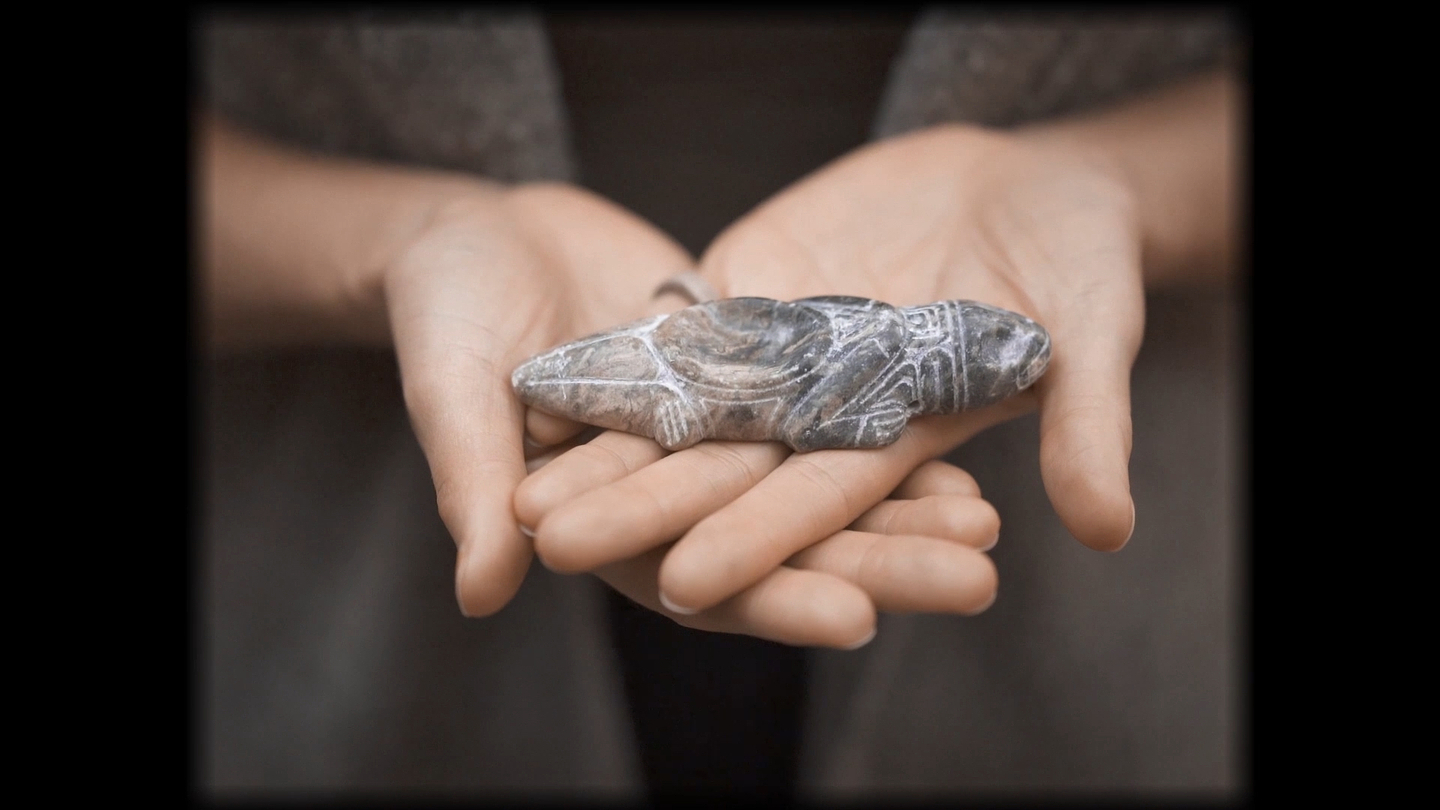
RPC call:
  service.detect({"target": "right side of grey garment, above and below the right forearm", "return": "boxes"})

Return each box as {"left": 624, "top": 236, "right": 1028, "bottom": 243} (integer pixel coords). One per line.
{"left": 802, "top": 9, "right": 1243, "bottom": 796}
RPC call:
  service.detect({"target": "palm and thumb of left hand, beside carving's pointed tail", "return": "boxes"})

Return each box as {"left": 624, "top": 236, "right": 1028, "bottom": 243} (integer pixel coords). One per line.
{"left": 383, "top": 183, "right": 693, "bottom": 615}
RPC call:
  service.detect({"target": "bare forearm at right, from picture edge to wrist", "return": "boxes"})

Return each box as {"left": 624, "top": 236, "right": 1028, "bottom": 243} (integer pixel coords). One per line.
{"left": 1025, "top": 74, "right": 1243, "bottom": 287}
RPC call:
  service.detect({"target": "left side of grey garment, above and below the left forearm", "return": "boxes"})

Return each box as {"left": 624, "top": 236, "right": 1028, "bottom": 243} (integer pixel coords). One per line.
{"left": 196, "top": 12, "right": 641, "bottom": 797}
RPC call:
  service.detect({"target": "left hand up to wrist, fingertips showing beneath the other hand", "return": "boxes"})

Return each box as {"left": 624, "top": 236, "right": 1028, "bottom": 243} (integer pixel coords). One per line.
{"left": 384, "top": 184, "right": 998, "bottom": 637}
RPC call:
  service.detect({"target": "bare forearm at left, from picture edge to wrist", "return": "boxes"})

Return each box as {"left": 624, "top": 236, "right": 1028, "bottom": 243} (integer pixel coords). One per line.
{"left": 197, "top": 115, "right": 492, "bottom": 347}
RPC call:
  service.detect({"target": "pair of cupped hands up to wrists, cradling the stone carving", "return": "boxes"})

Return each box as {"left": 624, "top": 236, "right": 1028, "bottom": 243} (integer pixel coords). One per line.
{"left": 384, "top": 125, "right": 1143, "bottom": 649}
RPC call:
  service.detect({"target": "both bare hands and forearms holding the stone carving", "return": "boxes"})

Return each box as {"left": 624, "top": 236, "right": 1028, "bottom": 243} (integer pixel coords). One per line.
{"left": 199, "top": 70, "right": 1236, "bottom": 647}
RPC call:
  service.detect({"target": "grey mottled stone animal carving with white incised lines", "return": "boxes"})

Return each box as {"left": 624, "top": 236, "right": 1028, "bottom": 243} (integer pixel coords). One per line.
{"left": 511, "top": 295, "right": 1050, "bottom": 453}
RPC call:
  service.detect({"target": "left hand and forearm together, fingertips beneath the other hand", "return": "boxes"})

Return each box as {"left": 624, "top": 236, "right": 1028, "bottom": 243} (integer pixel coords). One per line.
{"left": 199, "top": 120, "right": 998, "bottom": 647}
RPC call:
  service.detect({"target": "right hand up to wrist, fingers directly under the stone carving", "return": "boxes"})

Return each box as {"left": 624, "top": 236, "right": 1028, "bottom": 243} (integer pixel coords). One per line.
{"left": 517, "top": 127, "right": 1143, "bottom": 615}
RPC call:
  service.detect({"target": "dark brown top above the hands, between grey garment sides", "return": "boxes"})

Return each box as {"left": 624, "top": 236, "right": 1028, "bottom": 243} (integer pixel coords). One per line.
{"left": 546, "top": 7, "right": 914, "bottom": 255}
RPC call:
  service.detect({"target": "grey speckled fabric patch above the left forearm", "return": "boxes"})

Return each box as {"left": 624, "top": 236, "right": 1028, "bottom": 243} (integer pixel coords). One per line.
{"left": 197, "top": 10, "right": 575, "bottom": 182}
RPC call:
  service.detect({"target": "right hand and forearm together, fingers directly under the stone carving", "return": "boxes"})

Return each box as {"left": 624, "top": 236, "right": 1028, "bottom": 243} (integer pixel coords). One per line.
{"left": 516, "top": 70, "right": 1237, "bottom": 611}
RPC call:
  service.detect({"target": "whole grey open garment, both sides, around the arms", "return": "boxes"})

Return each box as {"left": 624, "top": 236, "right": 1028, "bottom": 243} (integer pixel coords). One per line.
{"left": 196, "top": 12, "right": 1244, "bottom": 797}
